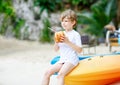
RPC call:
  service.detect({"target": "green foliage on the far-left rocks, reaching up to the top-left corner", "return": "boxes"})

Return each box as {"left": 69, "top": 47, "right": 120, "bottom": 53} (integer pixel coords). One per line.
{"left": 0, "top": 0, "right": 25, "bottom": 38}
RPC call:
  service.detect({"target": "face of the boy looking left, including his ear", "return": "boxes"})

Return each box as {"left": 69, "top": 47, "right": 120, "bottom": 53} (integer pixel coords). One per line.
{"left": 61, "top": 17, "right": 75, "bottom": 31}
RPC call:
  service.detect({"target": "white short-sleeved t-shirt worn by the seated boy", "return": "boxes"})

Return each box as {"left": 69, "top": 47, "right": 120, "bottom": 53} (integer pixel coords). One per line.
{"left": 58, "top": 30, "right": 82, "bottom": 65}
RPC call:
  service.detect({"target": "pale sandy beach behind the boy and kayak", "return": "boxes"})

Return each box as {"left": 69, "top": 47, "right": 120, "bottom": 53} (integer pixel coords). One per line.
{"left": 0, "top": 36, "right": 120, "bottom": 85}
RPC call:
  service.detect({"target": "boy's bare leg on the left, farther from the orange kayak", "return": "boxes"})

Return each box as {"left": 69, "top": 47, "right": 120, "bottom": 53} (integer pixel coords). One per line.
{"left": 41, "top": 63, "right": 63, "bottom": 85}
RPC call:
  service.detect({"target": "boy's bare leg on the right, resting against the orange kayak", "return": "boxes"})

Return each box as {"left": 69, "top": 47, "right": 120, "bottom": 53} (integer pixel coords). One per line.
{"left": 57, "top": 62, "right": 75, "bottom": 85}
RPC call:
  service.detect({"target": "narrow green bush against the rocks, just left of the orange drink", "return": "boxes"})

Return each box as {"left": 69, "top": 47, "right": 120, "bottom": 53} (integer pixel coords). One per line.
{"left": 40, "top": 18, "right": 52, "bottom": 43}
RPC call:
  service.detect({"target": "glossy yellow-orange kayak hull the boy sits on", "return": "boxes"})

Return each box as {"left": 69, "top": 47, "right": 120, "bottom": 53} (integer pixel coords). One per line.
{"left": 65, "top": 55, "right": 120, "bottom": 85}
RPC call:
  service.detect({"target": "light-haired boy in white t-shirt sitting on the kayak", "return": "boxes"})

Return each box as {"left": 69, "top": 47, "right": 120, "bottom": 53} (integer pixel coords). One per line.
{"left": 41, "top": 10, "right": 82, "bottom": 85}
